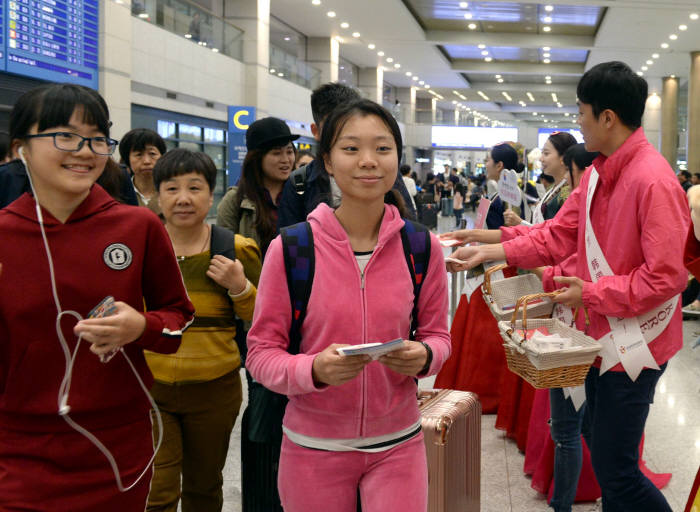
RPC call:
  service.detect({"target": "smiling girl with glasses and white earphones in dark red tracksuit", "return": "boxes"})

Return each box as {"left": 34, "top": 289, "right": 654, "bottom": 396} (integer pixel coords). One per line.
{"left": 0, "top": 84, "right": 194, "bottom": 512}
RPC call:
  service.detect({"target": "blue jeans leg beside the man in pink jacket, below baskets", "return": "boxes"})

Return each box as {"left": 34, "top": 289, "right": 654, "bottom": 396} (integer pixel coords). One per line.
{"left": 549, "top": 388, "right": 586, "bottom": 512}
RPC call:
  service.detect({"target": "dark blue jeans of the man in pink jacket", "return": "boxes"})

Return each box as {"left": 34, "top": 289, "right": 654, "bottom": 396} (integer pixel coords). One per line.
{"left": 583, "top": 364, "right": 672, "bottom": 512}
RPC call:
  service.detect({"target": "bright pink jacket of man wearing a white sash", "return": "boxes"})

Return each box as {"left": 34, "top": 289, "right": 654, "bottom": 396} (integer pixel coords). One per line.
{"left": 503, "top": 128, "right": 690, "bottom": 371}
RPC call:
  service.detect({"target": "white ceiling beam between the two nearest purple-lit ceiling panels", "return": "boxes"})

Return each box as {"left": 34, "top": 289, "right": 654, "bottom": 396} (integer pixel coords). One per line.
{"left": 425, "top": 30, "right": 595, "bottom": 50}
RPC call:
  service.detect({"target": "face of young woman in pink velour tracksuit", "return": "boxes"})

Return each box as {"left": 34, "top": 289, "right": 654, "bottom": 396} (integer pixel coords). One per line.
{"left": 324, "top": 114, "right": 399, "bottom": 206}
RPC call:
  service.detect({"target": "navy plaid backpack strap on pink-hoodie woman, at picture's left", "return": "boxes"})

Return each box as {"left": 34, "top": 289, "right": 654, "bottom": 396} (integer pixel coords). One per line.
{"left": 280, "top": 222, "right": 316, "bottom": 354}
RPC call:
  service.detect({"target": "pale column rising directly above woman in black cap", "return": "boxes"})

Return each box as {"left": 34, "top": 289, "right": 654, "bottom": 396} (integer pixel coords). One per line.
{"left": 225, "top": 0, "right": 270, "bottom": 118}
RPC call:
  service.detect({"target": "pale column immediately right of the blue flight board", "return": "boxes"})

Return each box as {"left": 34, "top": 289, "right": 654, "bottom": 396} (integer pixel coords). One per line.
{"left": 99, "top": 0, "right": 132, "bottom": 139}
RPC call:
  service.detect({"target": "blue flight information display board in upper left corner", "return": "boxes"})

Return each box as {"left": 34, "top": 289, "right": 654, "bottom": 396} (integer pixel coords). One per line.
{"left": 0, "top": 0, "right": 99, "bottom": 89}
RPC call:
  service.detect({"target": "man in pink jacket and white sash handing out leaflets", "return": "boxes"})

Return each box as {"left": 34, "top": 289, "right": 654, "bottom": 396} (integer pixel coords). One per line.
{"left": 450, "top": 62, "right": 689, "bottom": 512}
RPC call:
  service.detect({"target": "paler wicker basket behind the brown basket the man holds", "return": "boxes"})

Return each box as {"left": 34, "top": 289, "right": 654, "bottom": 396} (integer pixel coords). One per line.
{"left": 482, "top": 264, "right": 554, "bottom": 322}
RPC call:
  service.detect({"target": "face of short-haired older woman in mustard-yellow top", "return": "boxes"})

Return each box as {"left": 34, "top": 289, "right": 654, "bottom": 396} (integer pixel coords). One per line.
{"left": 158, "top": 172, "right": 214, "bottom": 228}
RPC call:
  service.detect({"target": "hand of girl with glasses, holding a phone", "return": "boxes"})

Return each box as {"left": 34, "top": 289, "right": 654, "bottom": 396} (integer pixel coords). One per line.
{"left": 73, "top": 302, "right": 146, "bottom": 355}
